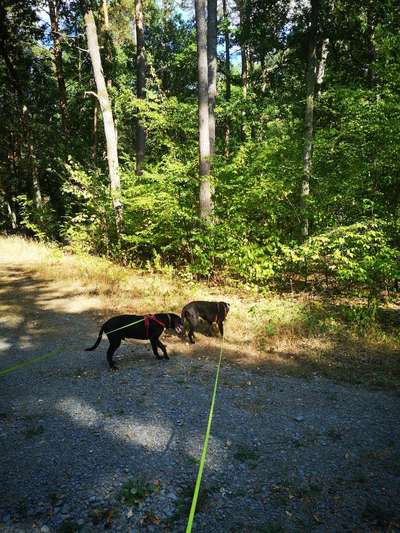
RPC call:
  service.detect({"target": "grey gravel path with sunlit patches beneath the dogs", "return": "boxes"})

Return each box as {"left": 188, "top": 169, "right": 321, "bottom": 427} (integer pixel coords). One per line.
{"left": 0, "top": 265, "right": 400, "bottom": 533}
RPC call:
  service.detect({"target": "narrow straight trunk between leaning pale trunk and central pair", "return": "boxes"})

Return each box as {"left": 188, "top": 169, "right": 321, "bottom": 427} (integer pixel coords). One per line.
{"left": 135, "top": 0, "right": 146, "bottom": 175}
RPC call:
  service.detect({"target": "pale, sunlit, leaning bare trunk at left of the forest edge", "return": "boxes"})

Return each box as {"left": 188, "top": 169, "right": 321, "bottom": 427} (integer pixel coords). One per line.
{"left": 84, "top": 10, "right": 122, "bottom": 230}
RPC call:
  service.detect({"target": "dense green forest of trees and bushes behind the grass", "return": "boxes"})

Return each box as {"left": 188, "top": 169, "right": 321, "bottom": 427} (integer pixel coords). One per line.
{"left": 0, "top": 0, "right": 400, "bottom": 301}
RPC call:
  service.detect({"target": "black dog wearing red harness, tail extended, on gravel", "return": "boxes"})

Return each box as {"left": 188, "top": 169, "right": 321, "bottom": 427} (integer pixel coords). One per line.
{"left": 85, "top": 313, "right": 183, "bottom": 370}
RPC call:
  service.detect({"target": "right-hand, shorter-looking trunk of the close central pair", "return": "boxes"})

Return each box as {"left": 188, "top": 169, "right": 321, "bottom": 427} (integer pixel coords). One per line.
{"left": 207, "top": 0, "right": 217, "bottom": 160}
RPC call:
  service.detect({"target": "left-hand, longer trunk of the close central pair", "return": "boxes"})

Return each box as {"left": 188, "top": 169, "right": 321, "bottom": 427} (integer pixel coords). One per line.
{"left": 195, "top": 0, "right": 213, "bottom": 220}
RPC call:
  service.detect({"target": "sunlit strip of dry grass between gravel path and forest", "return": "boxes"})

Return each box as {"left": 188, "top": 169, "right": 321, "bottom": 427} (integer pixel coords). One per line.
{"left": 0, "top": 237, "right": 400, "bottom": 390}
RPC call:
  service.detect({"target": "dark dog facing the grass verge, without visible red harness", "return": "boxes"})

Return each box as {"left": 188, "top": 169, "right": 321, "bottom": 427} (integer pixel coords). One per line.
{"left": 181, "top": 301, "right": 229, "bottom": 344}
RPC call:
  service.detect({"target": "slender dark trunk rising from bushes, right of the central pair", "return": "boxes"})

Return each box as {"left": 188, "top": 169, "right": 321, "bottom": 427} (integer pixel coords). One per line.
{"left": 300, "top": 0, "right": 319, "bottom": 239}
